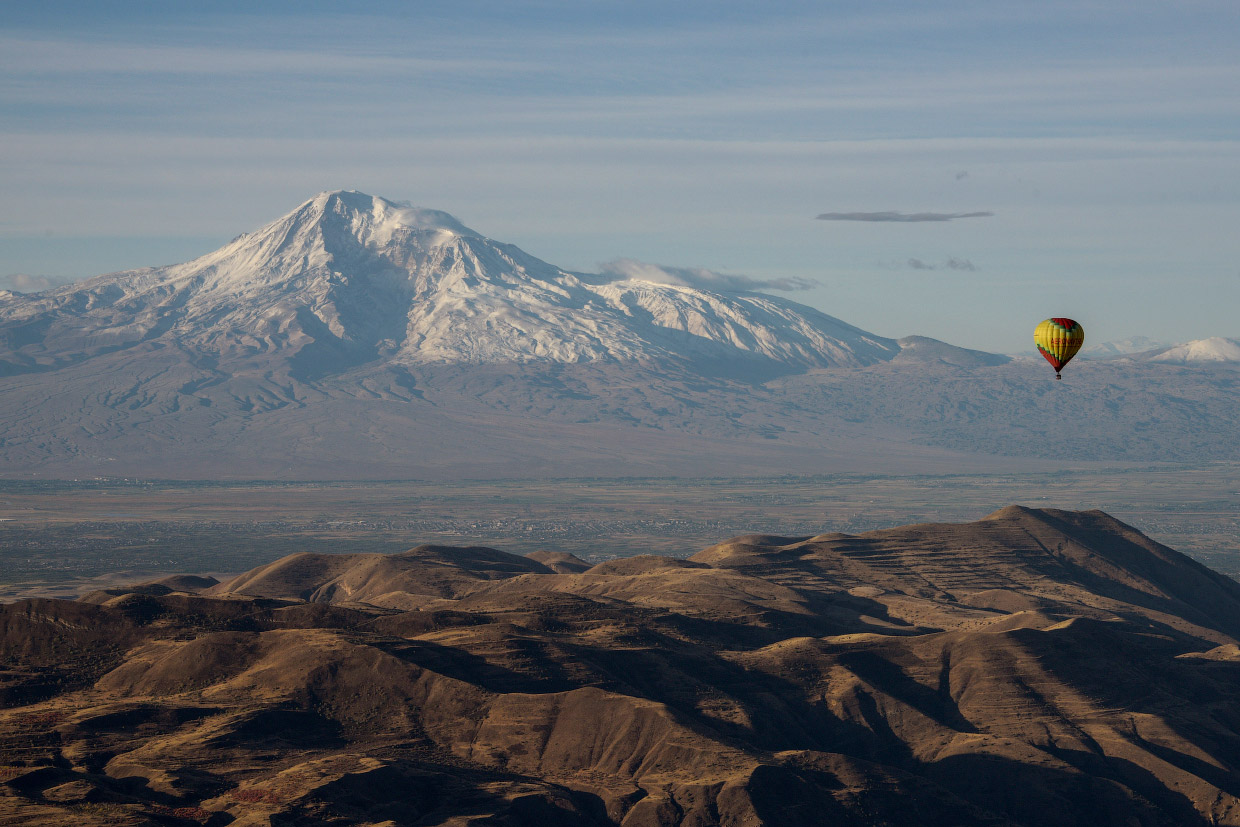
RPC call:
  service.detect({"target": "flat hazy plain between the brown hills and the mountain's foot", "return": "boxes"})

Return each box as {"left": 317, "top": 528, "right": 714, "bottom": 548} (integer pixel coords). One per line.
{"left": 0, "top": 462, "right": 1240, "bottom": 600}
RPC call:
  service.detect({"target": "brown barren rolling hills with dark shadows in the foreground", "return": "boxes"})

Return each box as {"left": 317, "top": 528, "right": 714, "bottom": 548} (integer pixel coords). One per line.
{"left": 0, "top": 506, "right": 1240, "bottom": 827}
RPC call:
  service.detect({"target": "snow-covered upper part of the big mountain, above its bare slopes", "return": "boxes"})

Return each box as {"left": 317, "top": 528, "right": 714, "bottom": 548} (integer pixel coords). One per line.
{"left": 0, "top": 192, "right": 900, "bottom": 377}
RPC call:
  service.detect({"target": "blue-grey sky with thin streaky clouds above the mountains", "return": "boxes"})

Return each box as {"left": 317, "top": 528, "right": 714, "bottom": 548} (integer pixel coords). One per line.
{"left": 0, "top": 0, "right": 1240, "bottom": 352}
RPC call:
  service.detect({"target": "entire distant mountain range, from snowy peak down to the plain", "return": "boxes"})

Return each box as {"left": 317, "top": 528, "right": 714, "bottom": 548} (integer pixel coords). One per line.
{"left": 0, "top": 192, "right": 1240, "bottom": 479}
